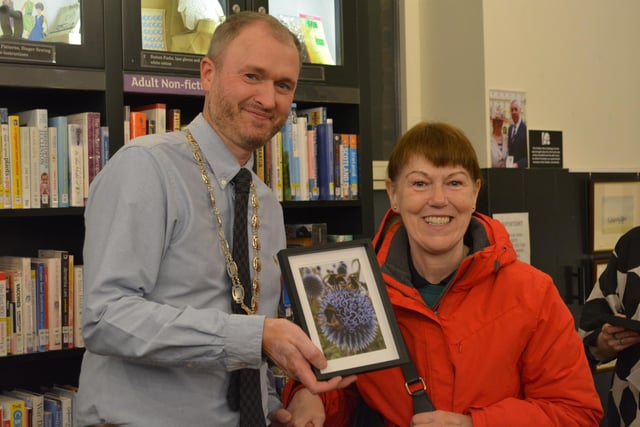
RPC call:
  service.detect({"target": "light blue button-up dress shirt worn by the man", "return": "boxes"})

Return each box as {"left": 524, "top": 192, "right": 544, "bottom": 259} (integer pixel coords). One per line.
{"left": 76, "top": 115, "right": 286, "bottom": 427}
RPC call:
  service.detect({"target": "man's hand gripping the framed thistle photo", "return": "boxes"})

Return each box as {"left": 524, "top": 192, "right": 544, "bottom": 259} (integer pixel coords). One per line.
{"left": 262, "top": 318, "right": 356, "bottom": 394}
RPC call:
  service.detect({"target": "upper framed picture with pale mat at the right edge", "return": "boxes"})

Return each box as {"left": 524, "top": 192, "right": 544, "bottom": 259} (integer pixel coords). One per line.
{"left": 589, "top": 181, "right": 640, "bottom": 252}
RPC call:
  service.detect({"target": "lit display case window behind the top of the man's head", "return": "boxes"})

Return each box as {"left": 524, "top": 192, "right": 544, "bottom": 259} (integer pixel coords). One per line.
{"left": 140, "top": 0, "right": 342, "bottom": 65}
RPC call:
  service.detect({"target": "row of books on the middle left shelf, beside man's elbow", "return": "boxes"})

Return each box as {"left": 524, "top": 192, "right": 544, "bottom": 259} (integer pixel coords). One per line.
{"left": 0, "top": 249, "right": 84, "bottom": 356}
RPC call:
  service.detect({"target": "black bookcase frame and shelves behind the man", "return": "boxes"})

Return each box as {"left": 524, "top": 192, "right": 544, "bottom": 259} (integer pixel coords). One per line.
{"left": 0, "top": 0, "right": 384, "bottom": 390}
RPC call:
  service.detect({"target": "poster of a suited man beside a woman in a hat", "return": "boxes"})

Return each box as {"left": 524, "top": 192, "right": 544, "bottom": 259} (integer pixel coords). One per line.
{"left": 489, "top": 89, "right": 529, "bottom": 168}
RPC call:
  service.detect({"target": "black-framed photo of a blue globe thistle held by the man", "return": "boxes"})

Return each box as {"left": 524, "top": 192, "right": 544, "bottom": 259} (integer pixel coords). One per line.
{"left": 278, "top": 240, "right": 408, "bottom": 380}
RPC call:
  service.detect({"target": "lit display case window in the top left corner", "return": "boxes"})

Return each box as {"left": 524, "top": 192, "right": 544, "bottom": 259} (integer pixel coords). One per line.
{"left": 0, "top": 0, "right": 82, "bottom": 45}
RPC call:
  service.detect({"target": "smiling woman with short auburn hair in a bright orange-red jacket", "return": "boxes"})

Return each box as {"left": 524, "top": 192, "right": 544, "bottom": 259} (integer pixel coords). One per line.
{"left": 284, "top": 123, "right": 603, "bottom": 427}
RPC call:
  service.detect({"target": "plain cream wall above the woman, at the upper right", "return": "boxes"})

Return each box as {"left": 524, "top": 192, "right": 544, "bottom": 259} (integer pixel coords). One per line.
{"left": 401, "top": 0, "right": 640, "bottom": 172}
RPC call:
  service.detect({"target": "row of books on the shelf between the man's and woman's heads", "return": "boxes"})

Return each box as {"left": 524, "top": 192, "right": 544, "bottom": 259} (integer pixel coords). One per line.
{"left": 255, "top": 103, "right": 358, "bottom": 201}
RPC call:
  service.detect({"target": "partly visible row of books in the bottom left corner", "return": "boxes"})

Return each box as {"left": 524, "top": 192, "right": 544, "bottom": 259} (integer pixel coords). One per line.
{"left": 0, "top": 385, "right": 77, "bottom": 427}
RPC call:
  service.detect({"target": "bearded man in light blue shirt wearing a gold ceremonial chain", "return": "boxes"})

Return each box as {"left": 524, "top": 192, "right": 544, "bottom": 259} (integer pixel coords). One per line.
{"left": 76, "top": 12, "right": 354, "bottom": 427}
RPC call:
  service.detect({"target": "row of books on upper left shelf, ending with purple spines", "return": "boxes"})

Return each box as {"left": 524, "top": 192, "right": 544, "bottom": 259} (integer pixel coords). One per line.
{"left": 0, "top": 108, "right": 109, "bottom": 209}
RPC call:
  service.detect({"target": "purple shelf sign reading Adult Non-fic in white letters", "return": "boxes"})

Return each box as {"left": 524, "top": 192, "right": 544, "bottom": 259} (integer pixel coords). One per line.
{"left": 123, "top": 74, "right": 204, "bottom": 95}
